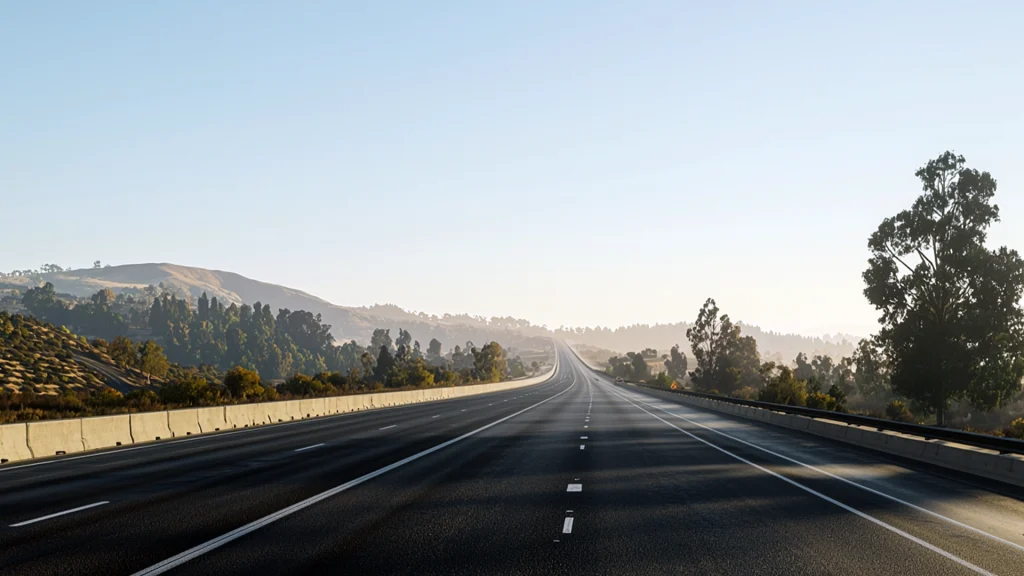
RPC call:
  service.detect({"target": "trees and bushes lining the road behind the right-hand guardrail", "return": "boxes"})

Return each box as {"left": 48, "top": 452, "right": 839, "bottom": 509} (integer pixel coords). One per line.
{"left": 608, "top": 152, "right": 1024, "bottom": 439}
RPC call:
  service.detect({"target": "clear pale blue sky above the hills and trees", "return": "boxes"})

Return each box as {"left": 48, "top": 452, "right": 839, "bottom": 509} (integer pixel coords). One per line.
{"left": 0, "top": 0, "right": 1024, "bottom": 335}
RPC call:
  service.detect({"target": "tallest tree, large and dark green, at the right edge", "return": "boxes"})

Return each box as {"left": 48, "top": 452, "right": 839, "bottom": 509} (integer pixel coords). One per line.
{"left": 863, "top": 152, "right": 1024, "bottom": 424}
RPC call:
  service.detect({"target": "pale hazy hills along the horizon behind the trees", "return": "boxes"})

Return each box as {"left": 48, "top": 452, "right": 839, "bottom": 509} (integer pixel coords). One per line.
{"left": 2, "top": 262, "right": 859, "bottom": 362}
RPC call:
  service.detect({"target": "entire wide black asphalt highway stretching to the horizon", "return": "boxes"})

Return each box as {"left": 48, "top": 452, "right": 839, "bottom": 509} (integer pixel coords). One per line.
{"left": 0, "top": 344, "right": 1024, "bottom": 576}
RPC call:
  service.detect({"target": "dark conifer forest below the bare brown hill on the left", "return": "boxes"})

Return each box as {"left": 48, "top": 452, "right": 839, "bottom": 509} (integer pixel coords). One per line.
{"left": 22, "top": 283, "right": 537, "bottom": 379}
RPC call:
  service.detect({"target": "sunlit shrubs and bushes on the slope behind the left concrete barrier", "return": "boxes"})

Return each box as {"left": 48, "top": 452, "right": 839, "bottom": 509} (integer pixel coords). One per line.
{"left": 0, "top": 307, "right": 542, "bottom": 423}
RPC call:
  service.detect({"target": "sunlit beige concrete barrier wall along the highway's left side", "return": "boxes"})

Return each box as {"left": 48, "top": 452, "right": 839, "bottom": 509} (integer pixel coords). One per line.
{"left": 0, "top": 356, "right": 555, "bottom": 462}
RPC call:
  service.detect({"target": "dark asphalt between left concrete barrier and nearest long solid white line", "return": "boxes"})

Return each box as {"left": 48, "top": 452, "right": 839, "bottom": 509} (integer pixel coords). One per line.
{"left": 0, "top": 360, "right": 571, "bottom": 575}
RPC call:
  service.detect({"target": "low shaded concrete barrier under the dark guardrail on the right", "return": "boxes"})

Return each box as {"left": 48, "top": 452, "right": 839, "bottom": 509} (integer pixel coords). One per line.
{"left": 647, "top": 393, "right": 1024, "bottom": 487}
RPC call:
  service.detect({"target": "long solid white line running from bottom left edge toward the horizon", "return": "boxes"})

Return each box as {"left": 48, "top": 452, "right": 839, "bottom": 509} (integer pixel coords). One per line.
{"left": 132, "top": 364, "right": 575, "bottom": 576}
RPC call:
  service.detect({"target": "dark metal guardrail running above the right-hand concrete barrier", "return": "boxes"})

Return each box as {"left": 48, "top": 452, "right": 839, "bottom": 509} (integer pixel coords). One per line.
{"left": 573, "top": 351, "right": 1024, "bottom": 454}
